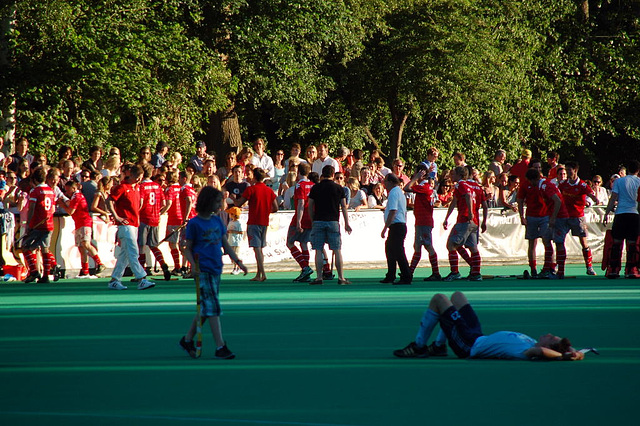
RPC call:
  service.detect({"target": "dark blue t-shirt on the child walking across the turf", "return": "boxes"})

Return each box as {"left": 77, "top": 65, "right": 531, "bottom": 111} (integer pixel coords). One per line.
{"left": 186, "top": 216, "right": 227, "bottom": 275}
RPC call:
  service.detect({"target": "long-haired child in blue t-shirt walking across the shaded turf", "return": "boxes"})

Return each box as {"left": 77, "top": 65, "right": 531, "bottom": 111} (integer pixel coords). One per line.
{"left": 180, "top": 186, "right": 247, "bottom": 359}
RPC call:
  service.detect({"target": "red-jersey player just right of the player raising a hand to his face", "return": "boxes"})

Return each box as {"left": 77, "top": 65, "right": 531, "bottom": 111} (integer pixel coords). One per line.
{"left": 442, "top": 166, "right": 487, "bottom": 281}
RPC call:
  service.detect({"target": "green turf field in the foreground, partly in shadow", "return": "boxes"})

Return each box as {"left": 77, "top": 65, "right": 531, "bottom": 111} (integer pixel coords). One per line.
{"left": 0, "top": 265, "right": 640, "bottom": 425}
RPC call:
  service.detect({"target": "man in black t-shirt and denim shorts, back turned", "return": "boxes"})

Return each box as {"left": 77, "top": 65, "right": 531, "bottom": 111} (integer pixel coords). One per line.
{"left": 309, "top": 166, "right": 351, "bottom": 285}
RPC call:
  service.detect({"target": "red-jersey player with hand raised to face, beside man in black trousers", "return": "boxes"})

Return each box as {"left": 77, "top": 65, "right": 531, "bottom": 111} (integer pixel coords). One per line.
{"left": 405, "top": 165, "right": 442, "bottom": 281}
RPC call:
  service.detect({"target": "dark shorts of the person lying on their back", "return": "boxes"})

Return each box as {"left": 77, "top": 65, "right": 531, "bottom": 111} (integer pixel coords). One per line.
{"left": 440, "top": 304, "right": 483, "bottom": 358}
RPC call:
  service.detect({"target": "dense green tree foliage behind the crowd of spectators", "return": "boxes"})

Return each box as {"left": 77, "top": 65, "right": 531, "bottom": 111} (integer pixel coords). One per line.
{"left": 0, "top": 0, "right": 640, "bottom": 175}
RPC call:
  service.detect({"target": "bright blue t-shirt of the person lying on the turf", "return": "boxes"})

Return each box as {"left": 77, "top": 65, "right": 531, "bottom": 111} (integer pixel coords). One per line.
{"left": 470, "top": 331, "right": 537, "bottom": 359}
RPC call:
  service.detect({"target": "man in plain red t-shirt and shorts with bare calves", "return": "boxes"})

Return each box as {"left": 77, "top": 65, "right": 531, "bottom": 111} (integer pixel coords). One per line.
{"left": 235, "top": 168, "right": 278, "bottom": 281}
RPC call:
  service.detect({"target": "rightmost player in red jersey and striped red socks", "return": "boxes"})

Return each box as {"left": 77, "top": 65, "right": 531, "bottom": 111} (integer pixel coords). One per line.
{"left": 558, "top": 161, "right": 598, "bottom": 275}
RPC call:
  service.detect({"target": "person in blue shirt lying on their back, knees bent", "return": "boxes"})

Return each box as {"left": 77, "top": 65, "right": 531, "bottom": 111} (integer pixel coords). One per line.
{"left": 393, "top": 291, "right": 584, "bottom": 361}
